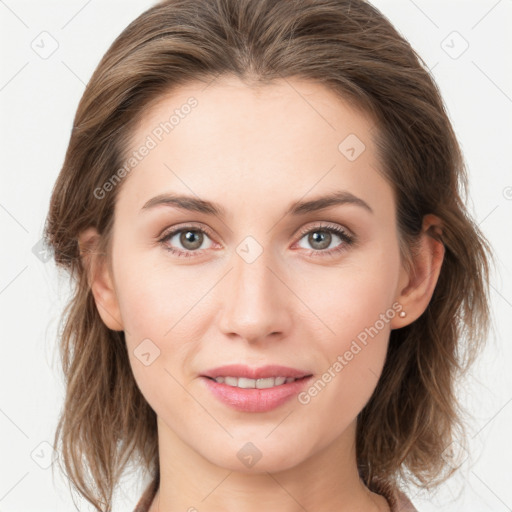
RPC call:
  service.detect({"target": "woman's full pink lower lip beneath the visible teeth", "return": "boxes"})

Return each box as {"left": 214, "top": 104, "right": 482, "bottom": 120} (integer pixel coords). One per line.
{"left": 201, "top": 376, "right": 311, "bottom": 412}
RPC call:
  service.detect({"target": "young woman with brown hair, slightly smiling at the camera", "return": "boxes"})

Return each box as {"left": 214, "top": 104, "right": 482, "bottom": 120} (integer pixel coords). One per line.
{"left": 46, "top": 0, "right": 491, "bottom": 512}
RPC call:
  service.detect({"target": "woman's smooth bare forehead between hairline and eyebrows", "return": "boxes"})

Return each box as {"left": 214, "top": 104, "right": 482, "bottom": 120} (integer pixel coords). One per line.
{"left": 118, "top": 77, "right": 394, "bottom": 218}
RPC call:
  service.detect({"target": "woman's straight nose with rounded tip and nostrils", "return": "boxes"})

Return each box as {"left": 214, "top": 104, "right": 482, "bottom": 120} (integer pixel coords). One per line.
{"left": 219, "top": 244, "right": 294, "bottom": 343}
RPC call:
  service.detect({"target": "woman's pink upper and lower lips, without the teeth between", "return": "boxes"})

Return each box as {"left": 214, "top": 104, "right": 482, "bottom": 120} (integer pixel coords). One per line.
{"left": 201, "top": 365, "right": 312, "bottom": 412}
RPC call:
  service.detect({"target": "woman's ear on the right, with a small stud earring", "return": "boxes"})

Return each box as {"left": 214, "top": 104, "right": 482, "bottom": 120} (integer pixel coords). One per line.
{"left": 391, "top": 214, "right": 445, "bottom": 329}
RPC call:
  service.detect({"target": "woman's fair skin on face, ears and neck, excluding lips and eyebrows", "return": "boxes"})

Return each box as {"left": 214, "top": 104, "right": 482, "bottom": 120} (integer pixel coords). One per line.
{"left": 80, "top": 77, "right": 444, "bottom": 512}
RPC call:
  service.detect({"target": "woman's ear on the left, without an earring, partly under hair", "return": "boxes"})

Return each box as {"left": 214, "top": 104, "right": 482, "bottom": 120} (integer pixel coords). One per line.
{"left": 78, "top": 227, "right": 124, "bottom": 331}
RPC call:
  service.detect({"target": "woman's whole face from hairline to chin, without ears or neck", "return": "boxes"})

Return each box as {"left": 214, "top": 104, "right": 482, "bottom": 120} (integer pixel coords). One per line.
{"left": 103, "top": 78, "right": 405, "bottom": 471}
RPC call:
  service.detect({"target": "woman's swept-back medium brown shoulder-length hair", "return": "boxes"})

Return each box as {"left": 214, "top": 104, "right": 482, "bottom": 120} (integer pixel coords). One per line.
{"left": 45, "top": 0, "right": 492, "bottom": 511}
